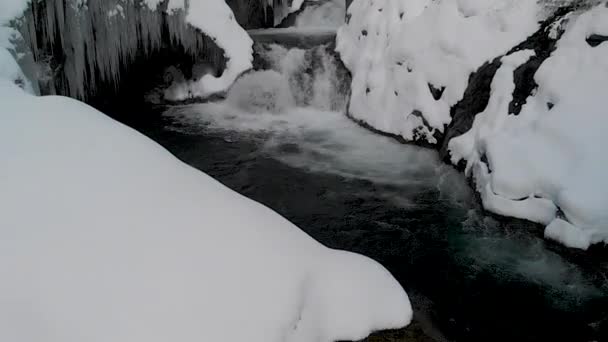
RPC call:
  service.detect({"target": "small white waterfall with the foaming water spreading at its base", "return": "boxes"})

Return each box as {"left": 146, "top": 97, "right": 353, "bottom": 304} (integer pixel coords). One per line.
{"left": 165, "top": 39, "right": 443, "bottom": 187}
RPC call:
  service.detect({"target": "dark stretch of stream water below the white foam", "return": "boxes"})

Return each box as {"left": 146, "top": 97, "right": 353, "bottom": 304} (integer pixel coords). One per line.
{"left": 117, "top": 105, "right": 608, "bottom": 341}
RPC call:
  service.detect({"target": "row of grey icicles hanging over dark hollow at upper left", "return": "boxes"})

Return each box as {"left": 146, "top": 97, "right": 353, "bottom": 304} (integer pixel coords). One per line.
{"left": 21, "top": 0, "right": 228, "bottom": 99}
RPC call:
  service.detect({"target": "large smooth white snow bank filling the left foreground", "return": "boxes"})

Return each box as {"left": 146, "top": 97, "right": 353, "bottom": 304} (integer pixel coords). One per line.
{"left": 0, "top": 3, "right": 412, "bottom": 342}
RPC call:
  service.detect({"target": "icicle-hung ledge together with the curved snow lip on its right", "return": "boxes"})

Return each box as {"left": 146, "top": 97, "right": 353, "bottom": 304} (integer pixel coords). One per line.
{"left": 17, "top": 0, "right": 252, "bottom": 98}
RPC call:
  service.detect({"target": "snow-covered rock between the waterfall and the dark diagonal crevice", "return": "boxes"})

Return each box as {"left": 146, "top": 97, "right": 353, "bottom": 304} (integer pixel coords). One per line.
{"left": 337, "top": 0, "right": 539, "bottom": 143}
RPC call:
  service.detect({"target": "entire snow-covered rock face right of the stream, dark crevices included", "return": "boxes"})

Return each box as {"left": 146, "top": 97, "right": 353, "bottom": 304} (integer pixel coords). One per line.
{"left": 338, "top": 0, "right": 608, "bottom": 249}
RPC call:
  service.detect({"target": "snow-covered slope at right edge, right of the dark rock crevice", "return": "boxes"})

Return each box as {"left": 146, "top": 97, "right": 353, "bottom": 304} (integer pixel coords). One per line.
{"left": 449, "top": 5, "right": 608, "bottom": 249}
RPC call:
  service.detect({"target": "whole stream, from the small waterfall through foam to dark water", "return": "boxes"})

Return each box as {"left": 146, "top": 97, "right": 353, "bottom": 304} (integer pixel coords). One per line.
{"left": 115, "top": 29, "right": 608, "bottom": 342}
